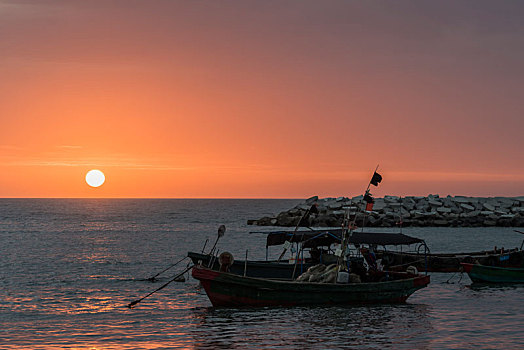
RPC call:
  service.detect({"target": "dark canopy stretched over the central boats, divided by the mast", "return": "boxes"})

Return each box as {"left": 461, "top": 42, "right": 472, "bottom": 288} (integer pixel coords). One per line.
{"left": 264, "top": 229, "right": 424, "bottom": 248}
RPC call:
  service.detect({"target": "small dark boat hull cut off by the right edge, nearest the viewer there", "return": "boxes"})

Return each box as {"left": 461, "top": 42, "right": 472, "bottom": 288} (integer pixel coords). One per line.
{"left": 461, "top": 263, "right": 524, "bottom": 283}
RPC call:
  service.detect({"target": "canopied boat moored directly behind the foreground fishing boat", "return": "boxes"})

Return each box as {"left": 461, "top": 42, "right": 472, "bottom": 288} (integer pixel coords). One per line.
{"left": 188, "top": 229, "right": 423, "bottom": 280}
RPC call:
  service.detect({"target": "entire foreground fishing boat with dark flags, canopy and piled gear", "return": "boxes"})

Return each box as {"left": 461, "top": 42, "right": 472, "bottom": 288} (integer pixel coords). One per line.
{"left": 192, "top": 166, "right": 430, "bottom": 307}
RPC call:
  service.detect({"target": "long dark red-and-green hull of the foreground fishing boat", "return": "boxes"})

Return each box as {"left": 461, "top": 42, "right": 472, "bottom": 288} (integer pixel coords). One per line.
{"left": 192, "top": 266, "right": 430, "bottom": 307}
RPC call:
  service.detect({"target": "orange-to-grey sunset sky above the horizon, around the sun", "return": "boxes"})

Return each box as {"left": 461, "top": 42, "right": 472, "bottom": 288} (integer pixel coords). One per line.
{"left": 0, "top": 0, "right": 524, "bottom": 198}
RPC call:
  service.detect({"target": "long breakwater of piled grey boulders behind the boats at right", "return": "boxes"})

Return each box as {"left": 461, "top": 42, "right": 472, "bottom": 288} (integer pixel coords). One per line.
{"left": 248, "top": 194, "right": 524, "bottom": 227}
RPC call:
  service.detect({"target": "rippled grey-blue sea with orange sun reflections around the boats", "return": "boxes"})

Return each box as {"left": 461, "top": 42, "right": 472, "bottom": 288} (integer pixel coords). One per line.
{"left": 0, "top": 199, "right": 524, "bottom": 349}
